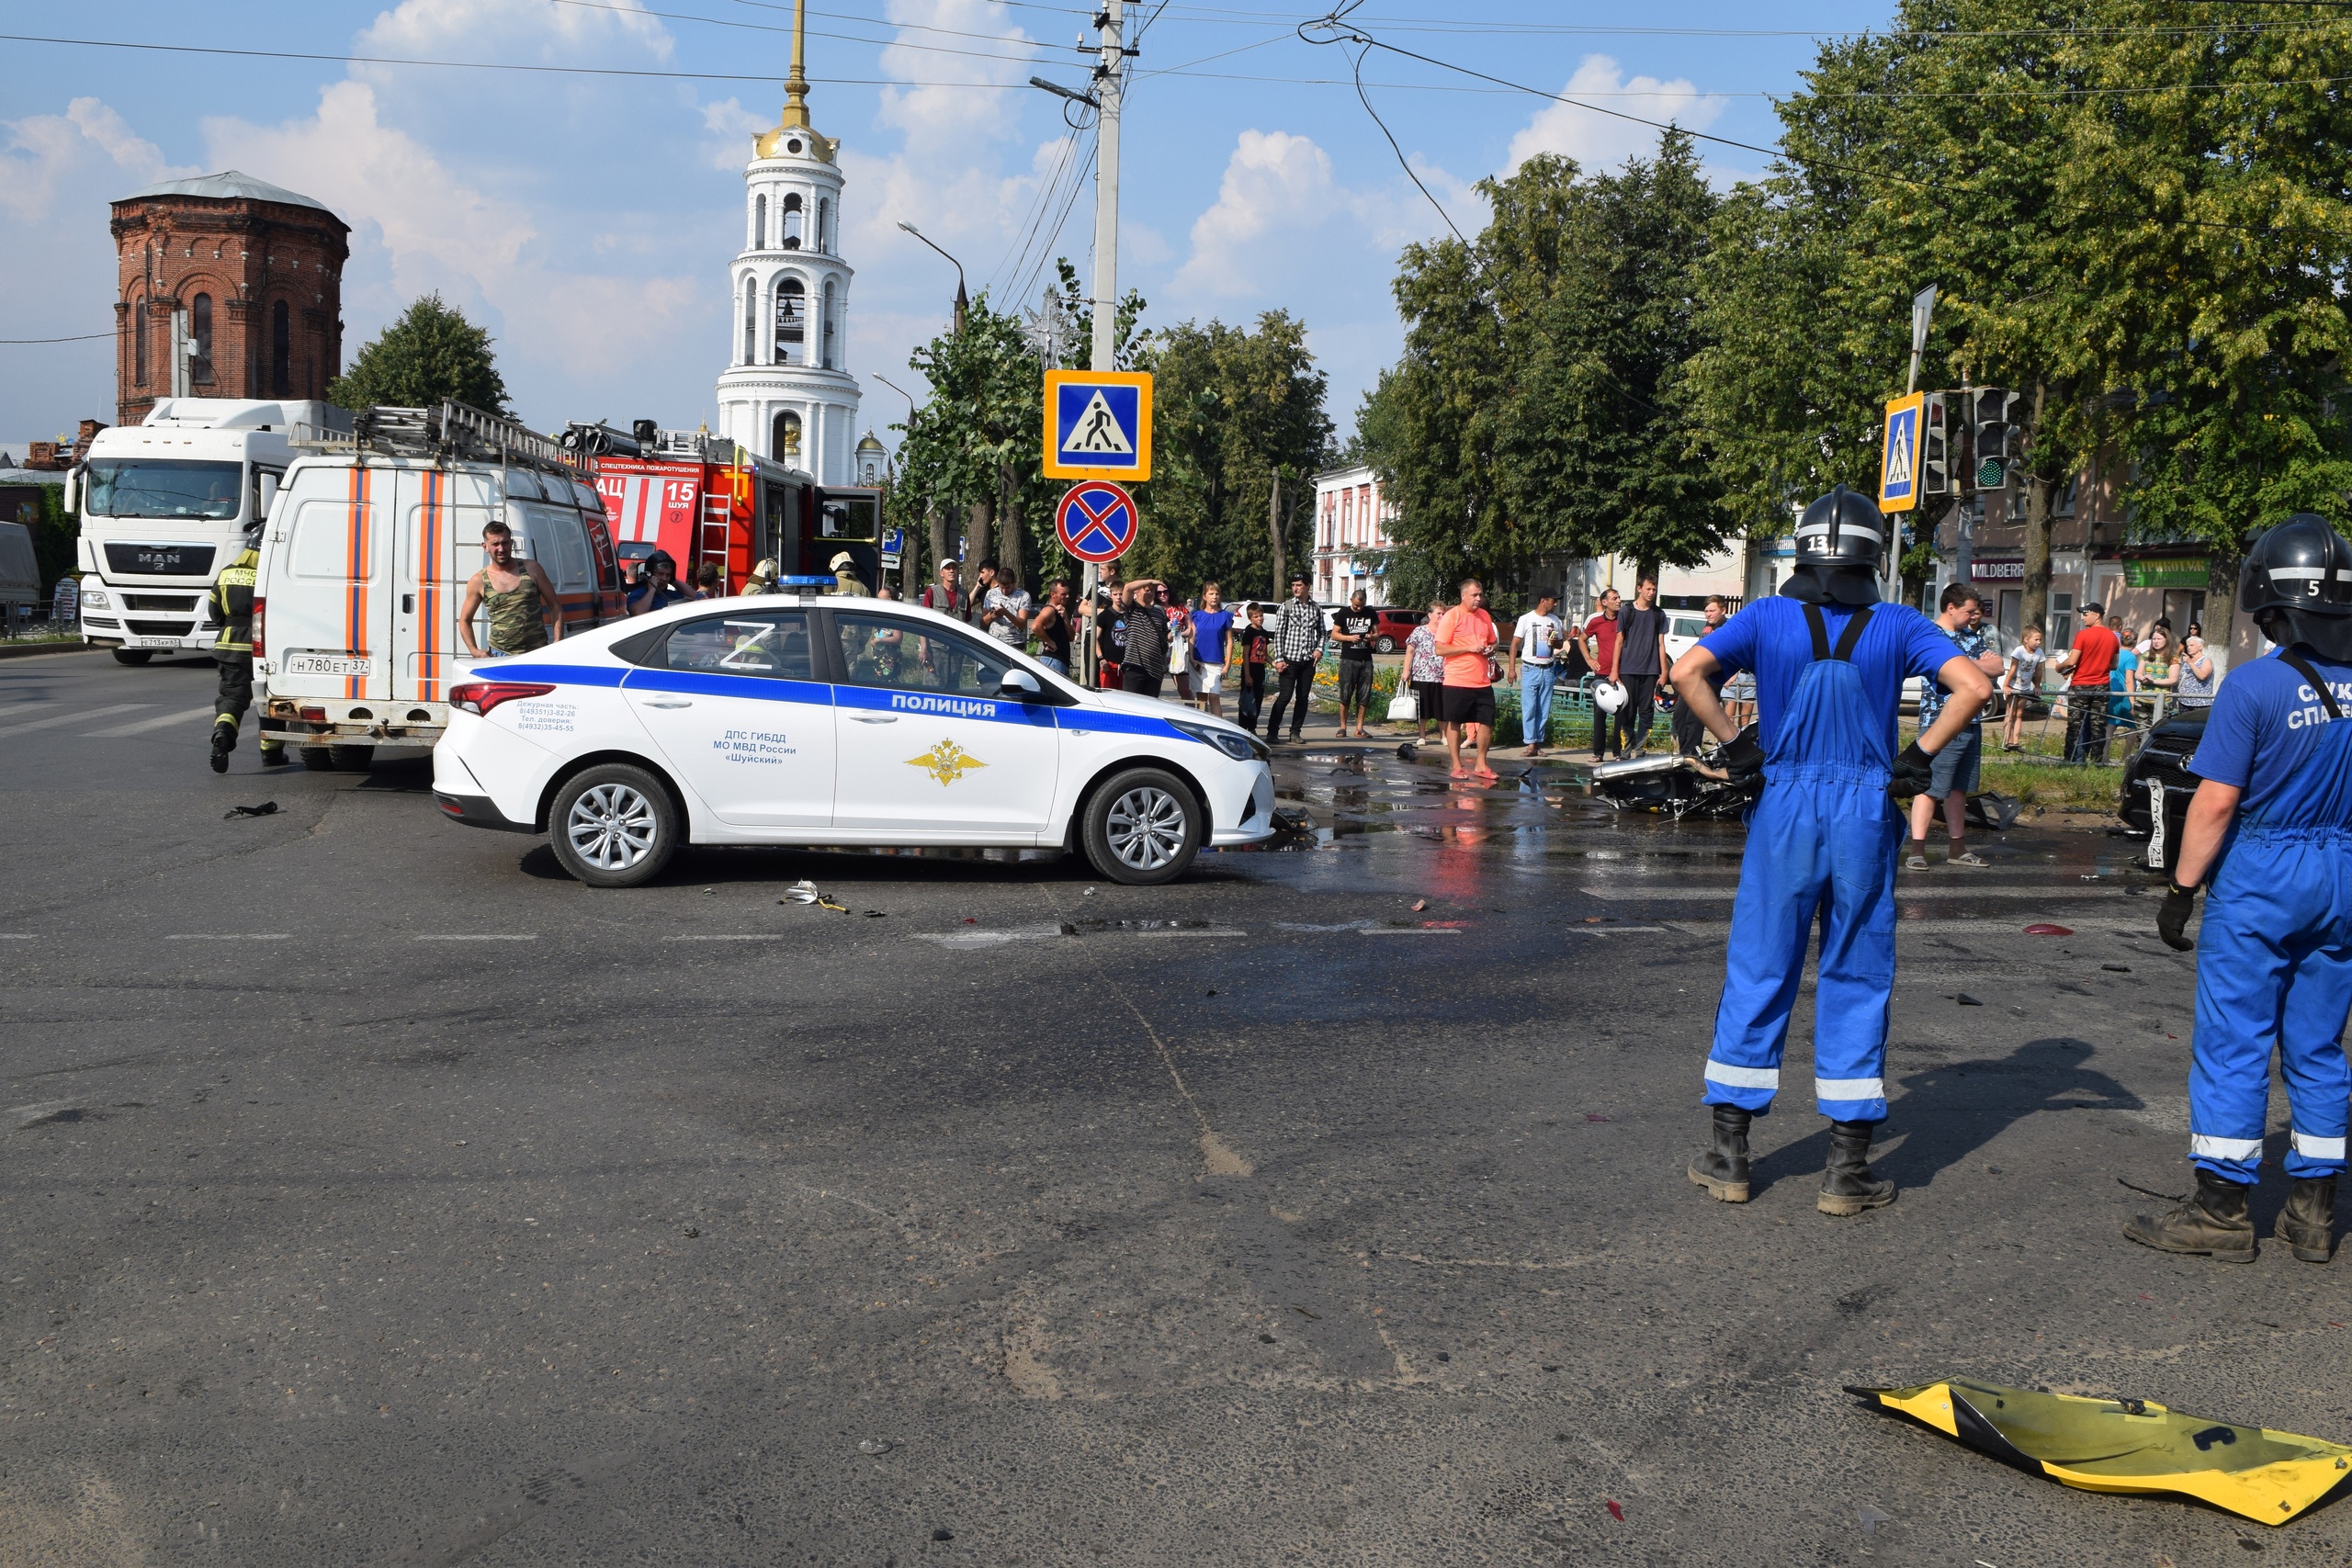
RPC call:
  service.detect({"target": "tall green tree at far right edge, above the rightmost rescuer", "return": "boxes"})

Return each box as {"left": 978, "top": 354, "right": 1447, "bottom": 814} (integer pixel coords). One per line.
{"left": 2051, "top": 0, "right": 2352, "bottom": 649}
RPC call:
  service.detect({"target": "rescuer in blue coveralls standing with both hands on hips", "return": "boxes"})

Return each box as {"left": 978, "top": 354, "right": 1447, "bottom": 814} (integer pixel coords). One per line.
{"left": 1675, "top": 487, "right": 1992, "bottom": 1215}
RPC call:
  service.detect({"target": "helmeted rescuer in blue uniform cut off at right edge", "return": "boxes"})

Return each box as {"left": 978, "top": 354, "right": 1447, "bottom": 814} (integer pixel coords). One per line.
{"left": 2124, "top": 513, "right": 2352, "bottom": 1262}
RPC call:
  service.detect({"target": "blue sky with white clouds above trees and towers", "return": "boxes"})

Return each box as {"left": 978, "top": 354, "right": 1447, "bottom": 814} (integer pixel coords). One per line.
{"left": 0, "top": 0, "right": 1886, "bottom": 446}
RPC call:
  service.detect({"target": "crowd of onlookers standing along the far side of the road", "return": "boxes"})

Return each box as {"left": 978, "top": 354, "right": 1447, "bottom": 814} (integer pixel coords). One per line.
{"left": 653, "top": 550, "right": 2221, "bottom": 778}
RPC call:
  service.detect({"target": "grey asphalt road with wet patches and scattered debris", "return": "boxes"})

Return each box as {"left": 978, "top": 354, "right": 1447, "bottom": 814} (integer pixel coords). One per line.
{"left": 0, "top": 656, "right": 2352, "bottom": 1568}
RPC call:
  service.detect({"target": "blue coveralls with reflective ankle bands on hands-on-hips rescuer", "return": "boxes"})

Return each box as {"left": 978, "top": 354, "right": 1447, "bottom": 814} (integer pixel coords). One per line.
{"left": 1705, "top": 604, "right": 1903, "bottom": 1122}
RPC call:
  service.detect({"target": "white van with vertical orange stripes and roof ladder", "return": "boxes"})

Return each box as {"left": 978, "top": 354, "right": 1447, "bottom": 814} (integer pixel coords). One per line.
{"left": 254, "top": 402, "right": 626, "bottom": 769}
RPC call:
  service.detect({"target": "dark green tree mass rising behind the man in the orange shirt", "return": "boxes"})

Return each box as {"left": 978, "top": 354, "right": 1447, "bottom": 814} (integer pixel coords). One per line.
{"left": 1357, "top": 131, "right": 1722, "bottom": 592}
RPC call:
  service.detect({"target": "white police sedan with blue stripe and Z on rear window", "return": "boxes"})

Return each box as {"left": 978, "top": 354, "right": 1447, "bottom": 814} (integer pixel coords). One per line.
{"left": 433, "top": 594, "right": 1275, "bottom": 886}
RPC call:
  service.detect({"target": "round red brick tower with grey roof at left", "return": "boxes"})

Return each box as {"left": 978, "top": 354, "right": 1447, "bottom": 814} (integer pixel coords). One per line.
{"left": 113, "top": 169, "right": 350, "bottom": 425}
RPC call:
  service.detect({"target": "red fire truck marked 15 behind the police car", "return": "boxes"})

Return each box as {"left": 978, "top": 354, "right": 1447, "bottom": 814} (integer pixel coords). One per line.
{"left": 562, "top": 419, "right": 882, "bottom": 592}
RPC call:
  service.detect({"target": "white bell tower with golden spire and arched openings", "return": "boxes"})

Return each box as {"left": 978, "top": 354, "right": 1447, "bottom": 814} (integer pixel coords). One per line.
{"left": 718, "top": 0, "right": 858, "bottom": 484}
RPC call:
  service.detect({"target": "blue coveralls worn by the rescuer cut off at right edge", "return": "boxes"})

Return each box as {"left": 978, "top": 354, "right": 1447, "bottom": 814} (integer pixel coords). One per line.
{"left": 2189, "top": 677, "right": 2352, "bottom": 1182}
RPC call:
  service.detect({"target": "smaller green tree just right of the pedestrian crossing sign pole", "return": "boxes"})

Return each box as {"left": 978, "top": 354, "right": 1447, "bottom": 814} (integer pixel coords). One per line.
{"left": 1126, "top": 310, "right": 1331, "bottom": 597}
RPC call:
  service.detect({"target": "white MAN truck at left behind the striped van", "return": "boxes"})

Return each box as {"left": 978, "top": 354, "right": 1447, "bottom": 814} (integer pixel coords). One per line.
{"left": 66, "top": 398, "right": 350, "bottom": 665}
